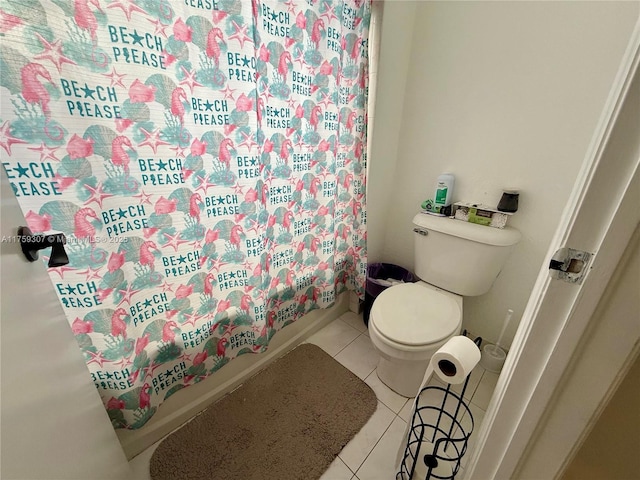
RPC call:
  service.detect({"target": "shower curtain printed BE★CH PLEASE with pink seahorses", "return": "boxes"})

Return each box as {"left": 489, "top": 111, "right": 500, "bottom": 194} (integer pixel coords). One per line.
{"left": 0, "top": 0, "right": 370, "bottom": 428}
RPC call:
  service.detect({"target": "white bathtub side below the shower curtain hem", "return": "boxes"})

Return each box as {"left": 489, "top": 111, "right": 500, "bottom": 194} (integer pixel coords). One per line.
{"left": 116, "top": 292, "right": 349, "bottom": 460}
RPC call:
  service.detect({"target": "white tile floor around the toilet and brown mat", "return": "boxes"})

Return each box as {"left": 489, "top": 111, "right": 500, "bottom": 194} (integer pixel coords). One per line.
{"left": 130, "top": 312, "right": 498, "bottom": 480}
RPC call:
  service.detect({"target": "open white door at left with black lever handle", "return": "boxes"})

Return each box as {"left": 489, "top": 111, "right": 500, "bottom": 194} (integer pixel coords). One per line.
{"left": 0, "top": 168, "right": 130, "bottom": 480}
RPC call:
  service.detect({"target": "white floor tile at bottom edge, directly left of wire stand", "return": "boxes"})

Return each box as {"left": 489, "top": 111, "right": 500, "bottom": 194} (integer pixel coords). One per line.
{"left": 356, "top": 417, "right": 407, "bottom": 480}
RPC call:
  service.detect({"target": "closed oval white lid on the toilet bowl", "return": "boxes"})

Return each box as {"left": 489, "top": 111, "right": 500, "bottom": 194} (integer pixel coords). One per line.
{"left": 371, "top": 283, "right": 460, "bottom": 345}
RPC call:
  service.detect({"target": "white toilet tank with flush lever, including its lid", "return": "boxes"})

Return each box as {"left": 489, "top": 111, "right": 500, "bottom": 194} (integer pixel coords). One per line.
{"left": 413, "top": 213, "right": 521, "bottom": 297}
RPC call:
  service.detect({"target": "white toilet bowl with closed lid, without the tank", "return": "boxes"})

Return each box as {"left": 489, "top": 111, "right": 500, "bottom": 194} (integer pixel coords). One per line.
{"left": 369, "top": 282, "right": 462, "bottom": 397}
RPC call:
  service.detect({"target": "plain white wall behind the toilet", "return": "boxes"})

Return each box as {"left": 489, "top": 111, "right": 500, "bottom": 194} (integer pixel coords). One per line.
{"left": 368, "top": 2, "right": 640, "bottom": 345}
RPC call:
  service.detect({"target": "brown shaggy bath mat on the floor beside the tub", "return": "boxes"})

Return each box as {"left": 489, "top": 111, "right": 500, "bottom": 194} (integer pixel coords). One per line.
{"left": 150, "top": 344, "right": 378, "bottom": 480}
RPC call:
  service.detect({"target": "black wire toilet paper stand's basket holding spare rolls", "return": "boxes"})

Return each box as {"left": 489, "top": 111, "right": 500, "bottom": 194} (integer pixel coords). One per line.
{"left": 396, "top": 337, "right": 482, "bottom": 480}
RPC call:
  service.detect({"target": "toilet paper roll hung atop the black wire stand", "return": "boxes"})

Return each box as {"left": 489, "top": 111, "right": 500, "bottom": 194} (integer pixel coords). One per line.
{"left": 430, "top": 335, "right": 481, "bottom": 384}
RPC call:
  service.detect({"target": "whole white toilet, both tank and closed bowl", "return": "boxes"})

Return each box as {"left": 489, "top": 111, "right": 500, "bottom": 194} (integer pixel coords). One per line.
{"left": 369, "top": 213, "right": 521, "bottom": 397}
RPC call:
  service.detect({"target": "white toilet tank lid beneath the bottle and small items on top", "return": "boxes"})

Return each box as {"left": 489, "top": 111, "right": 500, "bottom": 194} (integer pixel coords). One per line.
{"left": 413, "top": 213, "right": 522, "bottom": 247}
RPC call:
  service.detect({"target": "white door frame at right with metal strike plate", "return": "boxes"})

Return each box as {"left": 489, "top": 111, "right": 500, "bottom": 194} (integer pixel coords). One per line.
{"left": 465, "top": 21, "right": 640, "bottom": 480}
